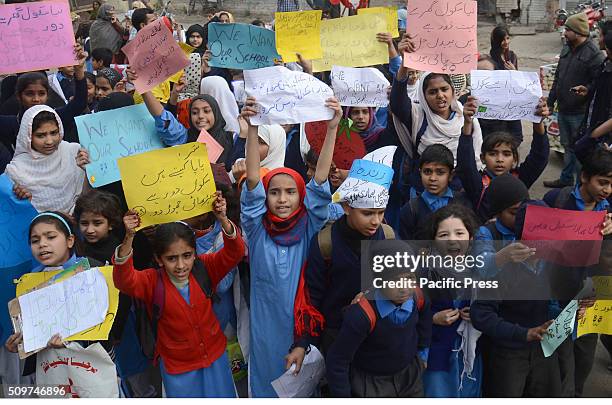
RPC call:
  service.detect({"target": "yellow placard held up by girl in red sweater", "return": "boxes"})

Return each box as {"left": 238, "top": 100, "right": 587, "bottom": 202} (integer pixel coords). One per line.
{"left": 117, "top": 142, "right": 217, "bottom": 227}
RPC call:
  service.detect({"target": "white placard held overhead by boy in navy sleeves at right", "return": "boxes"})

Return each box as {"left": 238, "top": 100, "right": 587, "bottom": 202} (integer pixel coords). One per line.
{"left": 471, "top": 70, "right": 542, "bottom": 122}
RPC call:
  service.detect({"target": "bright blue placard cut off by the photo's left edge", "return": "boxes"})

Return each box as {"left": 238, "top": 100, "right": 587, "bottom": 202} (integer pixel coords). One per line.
{"left": 0, "top": 174, "right": 37, "bottom": 269}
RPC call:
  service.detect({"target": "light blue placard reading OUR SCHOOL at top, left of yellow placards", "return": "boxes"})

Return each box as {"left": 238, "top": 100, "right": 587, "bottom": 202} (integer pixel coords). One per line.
{"left": 208, "top": 23, "right": 281, "bottom": 70}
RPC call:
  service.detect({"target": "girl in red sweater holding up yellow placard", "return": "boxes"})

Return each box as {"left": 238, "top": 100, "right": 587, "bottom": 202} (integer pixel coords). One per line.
{"left": 113, "top": 192, "right": 244, "bottom": 398}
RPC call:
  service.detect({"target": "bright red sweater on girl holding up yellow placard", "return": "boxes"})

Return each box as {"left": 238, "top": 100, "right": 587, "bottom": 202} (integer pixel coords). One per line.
{"left": 113, "top": 227, "right": 245, "bottom": 374}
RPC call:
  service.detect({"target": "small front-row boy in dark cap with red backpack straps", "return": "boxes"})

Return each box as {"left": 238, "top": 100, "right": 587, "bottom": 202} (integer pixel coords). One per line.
{"left": 326, "top": 241, "right": 432, "bottom": 398}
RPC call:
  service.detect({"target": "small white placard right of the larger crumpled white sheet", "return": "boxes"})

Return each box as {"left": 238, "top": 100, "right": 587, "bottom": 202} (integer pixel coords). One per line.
{"left": 331, "top": 66, "right": 391, "bottom": 107}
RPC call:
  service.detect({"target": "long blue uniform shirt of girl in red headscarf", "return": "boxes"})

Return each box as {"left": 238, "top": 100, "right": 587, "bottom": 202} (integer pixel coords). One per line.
{"left": 240, "top": 179, "right": 331, "bottom": 397}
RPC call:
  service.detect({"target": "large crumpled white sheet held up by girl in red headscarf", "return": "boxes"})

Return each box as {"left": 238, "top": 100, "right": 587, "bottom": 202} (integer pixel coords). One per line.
{"left": 244, "top": 66, "right": 334, "bottom": 125}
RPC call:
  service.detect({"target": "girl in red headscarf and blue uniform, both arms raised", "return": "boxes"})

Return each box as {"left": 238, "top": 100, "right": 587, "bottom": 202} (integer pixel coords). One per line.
{"left": 241, "top": 97, "right": 342, "bottom": 397}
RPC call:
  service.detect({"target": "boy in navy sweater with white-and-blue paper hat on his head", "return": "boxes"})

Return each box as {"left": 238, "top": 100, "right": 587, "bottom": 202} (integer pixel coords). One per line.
{"left": 287, "top": 146, "right": 396, "bottom": 362}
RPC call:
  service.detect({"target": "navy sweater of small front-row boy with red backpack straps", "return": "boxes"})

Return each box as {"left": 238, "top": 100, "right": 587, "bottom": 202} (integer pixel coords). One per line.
{"left": 326, "top": 301, "right": 432, "bottom": 397}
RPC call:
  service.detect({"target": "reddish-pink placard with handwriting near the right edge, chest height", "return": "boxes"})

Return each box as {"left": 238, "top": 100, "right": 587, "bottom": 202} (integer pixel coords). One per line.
{"left": 521, "top": 205, "right": 606, "bottom": 267}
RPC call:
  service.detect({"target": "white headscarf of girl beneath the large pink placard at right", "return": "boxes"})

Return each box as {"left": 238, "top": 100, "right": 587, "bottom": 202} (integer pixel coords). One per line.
{"left": 393, "top": 72, "right": 483, "bottom": 170}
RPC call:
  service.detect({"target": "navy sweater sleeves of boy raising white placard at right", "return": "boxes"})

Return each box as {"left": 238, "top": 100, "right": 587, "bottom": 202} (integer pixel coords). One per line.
{"left": 456, "top": 133, "right": 550, "bottom": 221}
